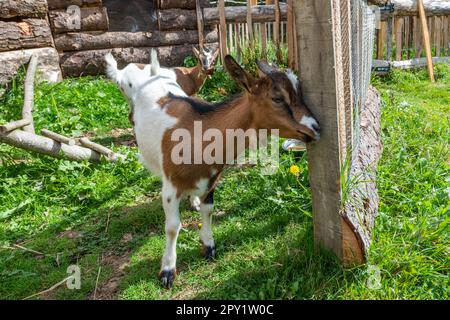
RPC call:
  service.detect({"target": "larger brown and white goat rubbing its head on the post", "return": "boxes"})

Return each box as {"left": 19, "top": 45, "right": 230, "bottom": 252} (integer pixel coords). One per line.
{"left": 107, "top": 56, "right": 320, "bottom": 287}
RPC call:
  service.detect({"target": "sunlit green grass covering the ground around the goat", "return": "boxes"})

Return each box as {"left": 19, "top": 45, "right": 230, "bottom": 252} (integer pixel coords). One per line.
{"left": 0, "top": 60, "right": 450, "bottom": 299}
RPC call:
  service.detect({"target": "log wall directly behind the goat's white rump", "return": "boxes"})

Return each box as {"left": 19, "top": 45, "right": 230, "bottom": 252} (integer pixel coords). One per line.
{"left": 48, "top": 0, "right": 218, "bottom": 77}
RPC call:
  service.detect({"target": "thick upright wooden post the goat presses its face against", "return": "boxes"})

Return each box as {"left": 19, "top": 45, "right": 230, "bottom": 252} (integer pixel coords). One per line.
{"left": 293, "top": 0, "right": 381, "bottom": 265}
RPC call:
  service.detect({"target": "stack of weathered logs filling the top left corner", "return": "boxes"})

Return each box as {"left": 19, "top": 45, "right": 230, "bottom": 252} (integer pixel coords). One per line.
{"left": 0, "top": 0, "right": 61, "bottom": 94}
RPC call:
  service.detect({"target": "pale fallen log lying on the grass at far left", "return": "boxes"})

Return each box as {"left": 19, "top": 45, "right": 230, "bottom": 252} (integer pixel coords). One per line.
{"left": 0, "top": 130, "right": 100, "bottom": 161}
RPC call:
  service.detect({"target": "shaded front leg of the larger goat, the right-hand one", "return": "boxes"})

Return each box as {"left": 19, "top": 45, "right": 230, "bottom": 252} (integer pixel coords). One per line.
{"left": 200, "top": 190, "right": 216, "bottom": 260}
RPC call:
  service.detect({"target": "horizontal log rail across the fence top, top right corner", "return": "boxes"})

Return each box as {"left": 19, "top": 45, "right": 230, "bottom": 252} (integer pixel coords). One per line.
{"left": 380, "top": 0, "right": 450, "bottom": 20}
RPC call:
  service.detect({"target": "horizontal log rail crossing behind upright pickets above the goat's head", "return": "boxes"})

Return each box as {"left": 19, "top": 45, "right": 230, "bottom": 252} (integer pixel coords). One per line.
{"left": 158, "top": 1, "right": 287, "bottom": 31}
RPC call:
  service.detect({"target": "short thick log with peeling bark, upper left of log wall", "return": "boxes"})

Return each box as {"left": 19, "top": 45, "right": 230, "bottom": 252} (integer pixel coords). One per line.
{"left": 49, "top": 7, "right": 109, "bottom": 34}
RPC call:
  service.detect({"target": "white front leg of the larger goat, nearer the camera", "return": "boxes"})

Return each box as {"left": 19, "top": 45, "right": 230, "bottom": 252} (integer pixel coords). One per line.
{"left": 159, "top": 181, "right": 181, "bottom": 288}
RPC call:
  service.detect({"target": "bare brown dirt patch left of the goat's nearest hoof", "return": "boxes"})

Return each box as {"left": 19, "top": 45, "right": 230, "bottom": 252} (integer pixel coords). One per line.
{"left": 87, "top": 251, "right": 131, "bottom": 300}
